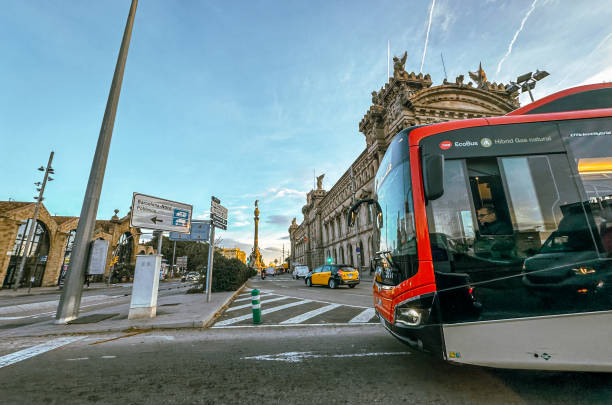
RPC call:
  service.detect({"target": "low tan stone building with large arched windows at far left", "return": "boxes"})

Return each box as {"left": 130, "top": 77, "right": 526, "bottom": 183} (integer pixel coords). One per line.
{"left": 0, "top": 201, "right": 143, "bottom": 288}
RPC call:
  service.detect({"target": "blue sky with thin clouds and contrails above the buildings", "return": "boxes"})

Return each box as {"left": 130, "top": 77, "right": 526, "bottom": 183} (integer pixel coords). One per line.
{"left": 0, "top": 0, "right": 612, "bottom": 260}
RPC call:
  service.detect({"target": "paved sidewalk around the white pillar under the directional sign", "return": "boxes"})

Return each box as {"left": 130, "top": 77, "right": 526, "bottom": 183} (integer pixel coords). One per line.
{"left": 0, "top": 283, "right": 246, "bottom": 338}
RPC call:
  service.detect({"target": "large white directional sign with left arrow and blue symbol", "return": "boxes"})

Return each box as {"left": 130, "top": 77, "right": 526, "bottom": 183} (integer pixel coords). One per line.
{"left": 130, "top": 193, "right": 193, "bottom": 233}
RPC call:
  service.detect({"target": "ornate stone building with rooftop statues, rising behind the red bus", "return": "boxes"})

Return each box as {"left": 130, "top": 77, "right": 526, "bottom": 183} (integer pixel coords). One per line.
{"left": 289, "top": 54, "right": 519, "bottom": 269}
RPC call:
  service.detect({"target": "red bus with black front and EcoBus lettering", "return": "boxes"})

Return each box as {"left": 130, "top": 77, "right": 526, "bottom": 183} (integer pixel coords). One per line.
{"left": 347, "top": 83, "right": 612, "bottom": 372}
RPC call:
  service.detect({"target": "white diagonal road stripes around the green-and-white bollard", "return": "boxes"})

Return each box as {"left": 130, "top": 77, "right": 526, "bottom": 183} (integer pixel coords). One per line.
{"left": 212, "top": 291, "right": 378, "bottom": 328}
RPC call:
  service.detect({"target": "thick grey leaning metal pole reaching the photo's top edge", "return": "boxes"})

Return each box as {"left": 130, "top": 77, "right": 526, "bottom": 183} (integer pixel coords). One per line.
{"left": 55, "top": 0, "right": 138, "bottom": 323}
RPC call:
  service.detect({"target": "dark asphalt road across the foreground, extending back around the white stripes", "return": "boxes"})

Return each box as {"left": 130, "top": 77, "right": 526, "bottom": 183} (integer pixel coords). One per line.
{"left": 0, "top": 278, "right": 612, "bottom": 404}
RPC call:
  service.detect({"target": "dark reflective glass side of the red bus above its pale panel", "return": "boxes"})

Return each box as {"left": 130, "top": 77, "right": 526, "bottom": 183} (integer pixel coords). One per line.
{"left": 420, "top": 117, "right": 612, "bottom": 323}
